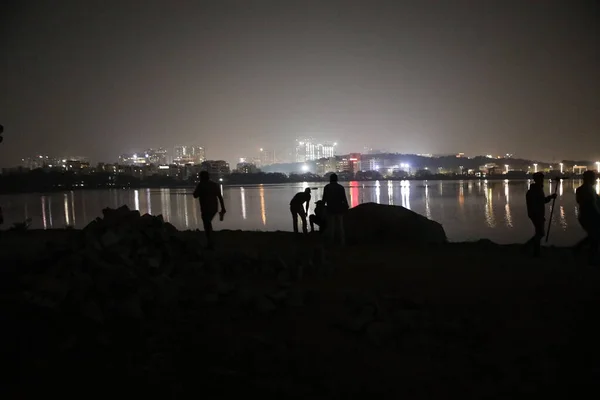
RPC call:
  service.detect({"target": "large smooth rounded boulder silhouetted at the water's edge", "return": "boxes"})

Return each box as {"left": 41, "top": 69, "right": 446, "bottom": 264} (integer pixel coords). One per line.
{"left": 344, "top": 203, "right": 447, "bottom": 243}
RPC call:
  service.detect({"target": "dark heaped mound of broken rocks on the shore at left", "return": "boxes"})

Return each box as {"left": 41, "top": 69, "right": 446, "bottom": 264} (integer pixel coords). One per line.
{"left": 23, "top": 206, "right": 203, "bottom": 323}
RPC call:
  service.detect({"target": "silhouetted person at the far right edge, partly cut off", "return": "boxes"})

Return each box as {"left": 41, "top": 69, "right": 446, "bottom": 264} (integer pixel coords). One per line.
{"left": 575, "top": 171, "right": 600, "bottom": 264}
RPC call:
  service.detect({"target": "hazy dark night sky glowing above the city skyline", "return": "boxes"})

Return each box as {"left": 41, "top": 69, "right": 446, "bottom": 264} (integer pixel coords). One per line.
{"left": 0, "top": 0, "right": 600, "bottom": 165}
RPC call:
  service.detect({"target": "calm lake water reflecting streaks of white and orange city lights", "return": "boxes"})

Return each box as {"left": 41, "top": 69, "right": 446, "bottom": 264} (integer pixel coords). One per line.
{"left": 0, "top": 180, "right": 599, "bottom": 245}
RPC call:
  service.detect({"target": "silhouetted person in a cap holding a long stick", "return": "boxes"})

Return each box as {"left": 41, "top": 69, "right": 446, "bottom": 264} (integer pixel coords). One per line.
{"left": 525, "top": 172, "right": 556, "bottom": 257}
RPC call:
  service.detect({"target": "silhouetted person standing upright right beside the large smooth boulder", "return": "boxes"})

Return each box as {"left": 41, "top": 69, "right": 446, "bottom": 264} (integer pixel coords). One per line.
{"left": 323, "top": 174, "right": 349, "bottom": 246}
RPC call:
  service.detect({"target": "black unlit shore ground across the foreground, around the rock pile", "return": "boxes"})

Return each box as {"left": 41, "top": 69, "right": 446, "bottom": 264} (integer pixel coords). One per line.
{"left": 0, "top": 231, "right": 600, "bottom": 399}
